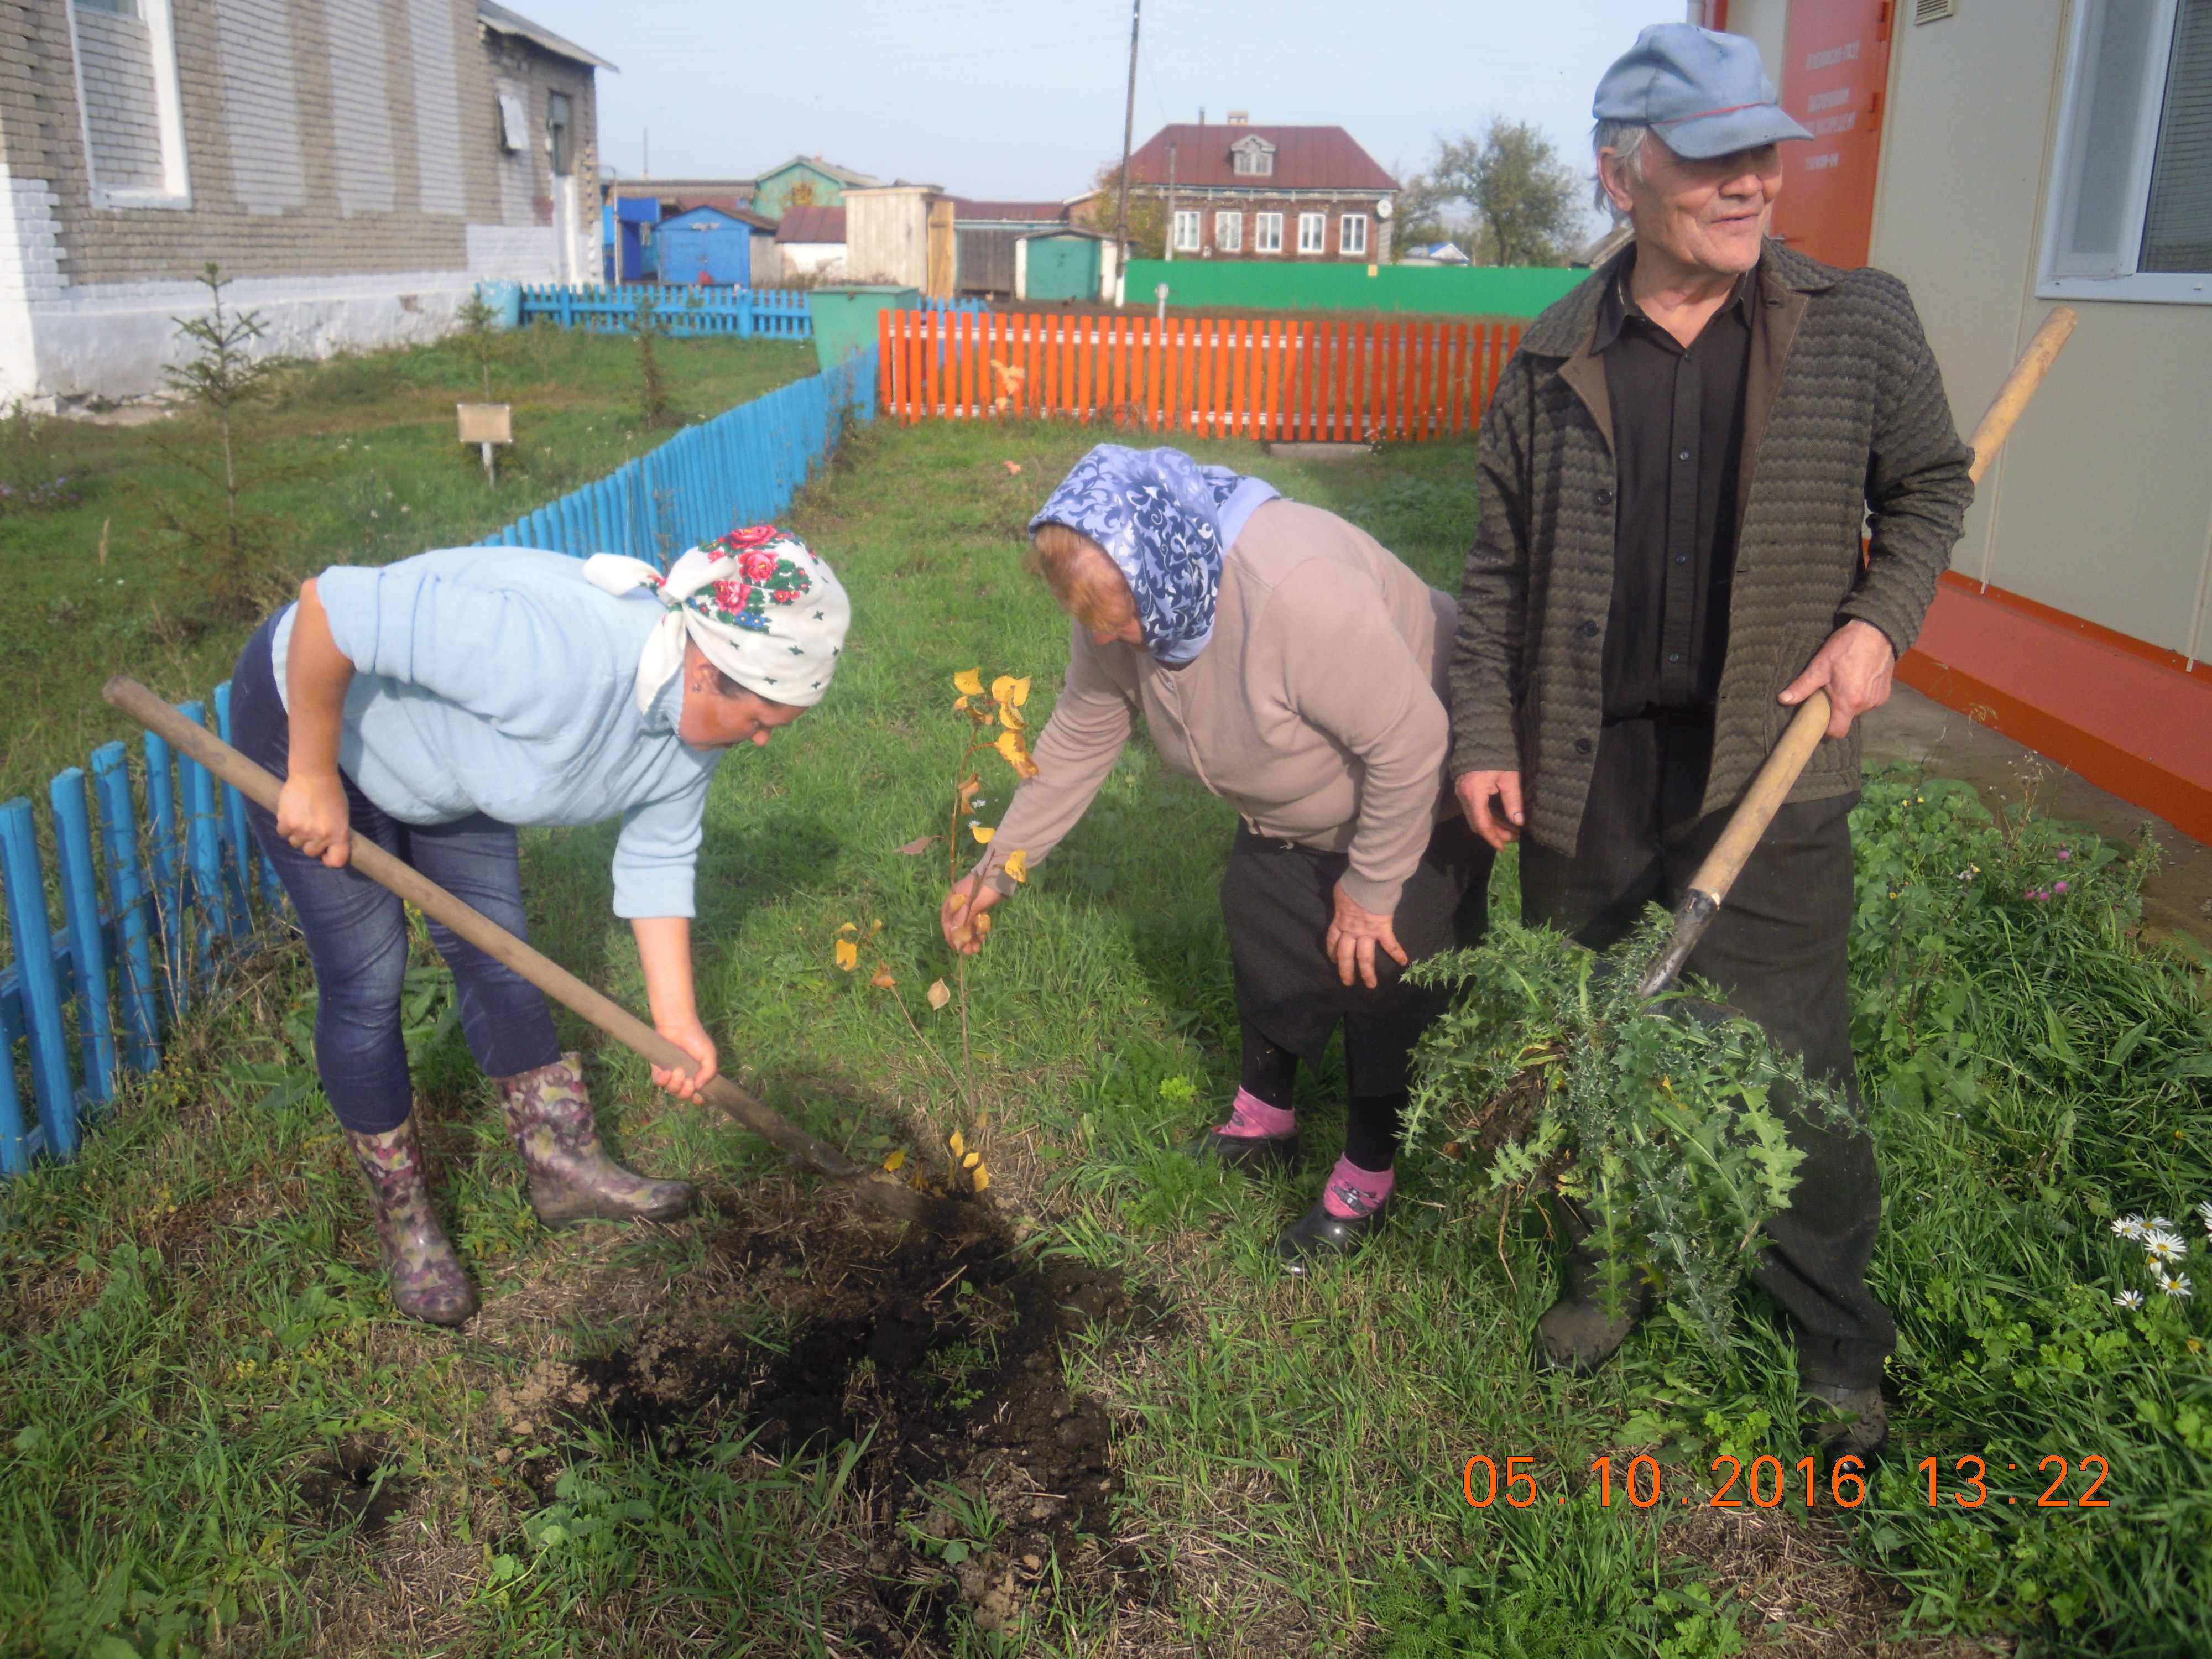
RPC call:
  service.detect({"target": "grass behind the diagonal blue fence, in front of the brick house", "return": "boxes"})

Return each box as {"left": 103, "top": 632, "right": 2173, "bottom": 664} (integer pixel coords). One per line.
{"left": 0, "top": 327, "right": 814, "bottom": 814}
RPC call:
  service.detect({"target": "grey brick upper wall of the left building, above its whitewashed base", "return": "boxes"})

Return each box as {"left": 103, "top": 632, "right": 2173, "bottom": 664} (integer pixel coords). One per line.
{"left": 0, "top": 0, "right": 597, "bottom": 288}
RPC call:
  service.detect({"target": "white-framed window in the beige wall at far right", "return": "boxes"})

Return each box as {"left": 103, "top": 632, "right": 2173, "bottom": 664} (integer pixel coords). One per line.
{"left": 2037, "top": 0, "right": 2212, "bottom": 303}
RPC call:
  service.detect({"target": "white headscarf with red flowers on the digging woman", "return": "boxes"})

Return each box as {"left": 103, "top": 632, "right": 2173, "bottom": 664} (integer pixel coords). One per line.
{"left": 584, "top": 524, "right": 852, "bottom": 714}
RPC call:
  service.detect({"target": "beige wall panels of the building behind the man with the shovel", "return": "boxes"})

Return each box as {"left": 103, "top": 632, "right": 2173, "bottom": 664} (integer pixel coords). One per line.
{"left": 1874, "top": 0, "right": 2212, "bottom": 650}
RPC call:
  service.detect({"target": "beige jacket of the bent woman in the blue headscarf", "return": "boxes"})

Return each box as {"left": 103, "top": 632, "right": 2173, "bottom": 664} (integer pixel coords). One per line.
{"left": 978, "top": 500, "right": 1458, "bottom": 916}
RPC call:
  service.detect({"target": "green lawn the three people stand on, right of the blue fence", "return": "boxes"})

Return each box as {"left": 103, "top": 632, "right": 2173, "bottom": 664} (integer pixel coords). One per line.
{"left": 0, "top": 409, "right": 2212, "bottom": 1659}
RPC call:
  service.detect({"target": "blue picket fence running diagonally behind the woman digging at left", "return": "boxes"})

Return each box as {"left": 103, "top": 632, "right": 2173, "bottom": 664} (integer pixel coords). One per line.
{"left": 0, "top": 347, "right": 876, "bottom": 1177}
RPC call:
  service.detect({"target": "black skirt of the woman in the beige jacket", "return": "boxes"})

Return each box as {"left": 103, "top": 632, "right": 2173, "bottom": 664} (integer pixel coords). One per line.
{"left": 1221, "top": 814, "right": 1498, "bottom": 1095}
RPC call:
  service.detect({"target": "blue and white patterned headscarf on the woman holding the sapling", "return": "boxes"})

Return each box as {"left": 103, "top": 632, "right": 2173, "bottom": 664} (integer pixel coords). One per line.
{"left": 1029, "top": 445, "right": 1279, "bottom": 668}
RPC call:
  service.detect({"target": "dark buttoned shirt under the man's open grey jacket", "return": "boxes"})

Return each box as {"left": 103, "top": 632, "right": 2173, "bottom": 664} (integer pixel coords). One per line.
{"left": 1590, "top": 259, "right": 1759, "bottom": 721}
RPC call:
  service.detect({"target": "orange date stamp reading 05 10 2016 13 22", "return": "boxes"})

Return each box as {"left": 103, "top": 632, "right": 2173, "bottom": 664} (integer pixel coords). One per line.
{"left": 1460, "top": 1453, "right": 2112, "bottom": 1509}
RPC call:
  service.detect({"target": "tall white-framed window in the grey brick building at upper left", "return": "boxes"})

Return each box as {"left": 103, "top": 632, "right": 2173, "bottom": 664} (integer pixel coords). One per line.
{"left": 69, "top": 0, "right": 190, "bottom": 208}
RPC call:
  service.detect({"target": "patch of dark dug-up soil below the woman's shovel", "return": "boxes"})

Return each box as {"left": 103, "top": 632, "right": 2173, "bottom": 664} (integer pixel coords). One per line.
{"left": 573, "top": 1197, "right": 1159, "bottom": 1655}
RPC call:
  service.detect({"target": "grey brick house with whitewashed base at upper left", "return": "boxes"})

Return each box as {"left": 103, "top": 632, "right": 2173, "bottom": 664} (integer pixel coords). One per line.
{"left": 0, "top": 0, "right": 613, "bottom": 405}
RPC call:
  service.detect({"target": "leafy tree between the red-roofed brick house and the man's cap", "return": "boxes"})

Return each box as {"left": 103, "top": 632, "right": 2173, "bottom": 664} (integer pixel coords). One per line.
{"left": 1398, "top": 115, "right": 1584, "bottom": 265}
